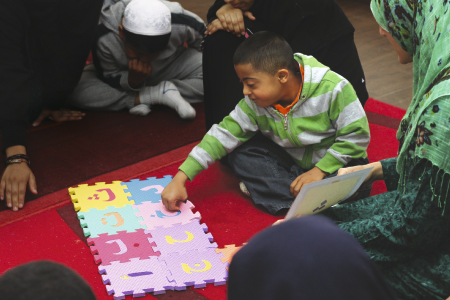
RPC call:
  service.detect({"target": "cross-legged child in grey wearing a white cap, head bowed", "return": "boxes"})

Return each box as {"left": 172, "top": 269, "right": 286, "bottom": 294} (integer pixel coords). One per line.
{"left": 70, "top": 0, "right": 206, "bottom": 119}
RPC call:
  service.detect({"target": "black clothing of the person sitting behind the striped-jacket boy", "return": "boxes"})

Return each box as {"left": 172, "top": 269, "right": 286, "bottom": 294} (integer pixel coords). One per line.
{"left": 203, "top": 0, "right": 369, "bottom": 130}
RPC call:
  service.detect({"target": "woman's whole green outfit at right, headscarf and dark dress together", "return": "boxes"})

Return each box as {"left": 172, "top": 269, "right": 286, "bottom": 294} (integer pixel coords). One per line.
{"left": 323, "top": 0, "right": 450, "bottom": 300}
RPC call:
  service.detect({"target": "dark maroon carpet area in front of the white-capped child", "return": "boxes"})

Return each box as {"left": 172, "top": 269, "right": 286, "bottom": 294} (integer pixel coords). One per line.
{"left": 0, "top": 103, "right": 206, "bottom": 213}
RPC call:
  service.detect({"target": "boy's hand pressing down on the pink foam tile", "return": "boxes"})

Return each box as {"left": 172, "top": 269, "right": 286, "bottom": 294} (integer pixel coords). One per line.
{"left": 161, "top": 171, "right": 189, "bottom": 210}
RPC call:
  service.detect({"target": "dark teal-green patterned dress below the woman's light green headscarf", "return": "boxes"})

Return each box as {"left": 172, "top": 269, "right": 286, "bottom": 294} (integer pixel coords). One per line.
{"left": 323, "top": 158, "right": 450, "bottom": 300}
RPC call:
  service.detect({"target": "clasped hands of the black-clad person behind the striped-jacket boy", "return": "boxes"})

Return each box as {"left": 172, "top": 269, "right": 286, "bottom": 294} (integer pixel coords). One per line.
{"left": 216, "top": 4, "right": 256, "bottom": 36}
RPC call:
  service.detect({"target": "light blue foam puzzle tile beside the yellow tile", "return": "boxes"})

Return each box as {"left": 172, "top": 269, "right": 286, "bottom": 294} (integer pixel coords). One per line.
{"left": 122, "top": 175, "right": 172, "bottom": 205}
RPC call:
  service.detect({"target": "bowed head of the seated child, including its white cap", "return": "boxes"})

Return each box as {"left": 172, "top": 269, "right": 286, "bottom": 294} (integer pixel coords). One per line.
{"left": 119, "top": 0, "right": 171, "bottom": 62}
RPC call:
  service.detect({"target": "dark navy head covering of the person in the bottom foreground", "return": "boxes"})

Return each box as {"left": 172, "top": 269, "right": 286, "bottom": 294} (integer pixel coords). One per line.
{"left": 228, "top": 215, "right": 396, "bottom": 300}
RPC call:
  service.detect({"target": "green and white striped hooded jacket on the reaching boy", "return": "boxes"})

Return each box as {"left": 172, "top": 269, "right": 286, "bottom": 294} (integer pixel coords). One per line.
{"left": 179, "top": 53, "right": 370, "bottom": 180}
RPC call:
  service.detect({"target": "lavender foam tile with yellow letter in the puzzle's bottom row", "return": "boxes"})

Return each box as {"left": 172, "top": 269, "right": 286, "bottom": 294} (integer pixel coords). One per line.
{"left": 158, "top": 248, "right": 228, "bottom": 290}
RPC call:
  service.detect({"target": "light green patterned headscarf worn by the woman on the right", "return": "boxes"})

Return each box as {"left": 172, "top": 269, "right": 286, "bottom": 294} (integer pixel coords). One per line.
{"left": 370, "top": 0, "right": 450, "bottom": 206}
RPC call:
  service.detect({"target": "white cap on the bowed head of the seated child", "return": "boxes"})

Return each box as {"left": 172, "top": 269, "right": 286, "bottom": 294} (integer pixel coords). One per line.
{"left": 123, "top": 0, "right": 172, "bottom": 36}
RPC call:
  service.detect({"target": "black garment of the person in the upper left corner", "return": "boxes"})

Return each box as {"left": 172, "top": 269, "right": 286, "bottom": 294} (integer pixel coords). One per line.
{"left": 0, "top": 0, "right": 103, "bottom": 151}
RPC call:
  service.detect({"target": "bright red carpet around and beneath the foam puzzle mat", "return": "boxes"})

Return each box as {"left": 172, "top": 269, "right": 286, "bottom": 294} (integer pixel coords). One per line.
{"left": 0, "top": 100, "right": 404, "bottom": 300}
